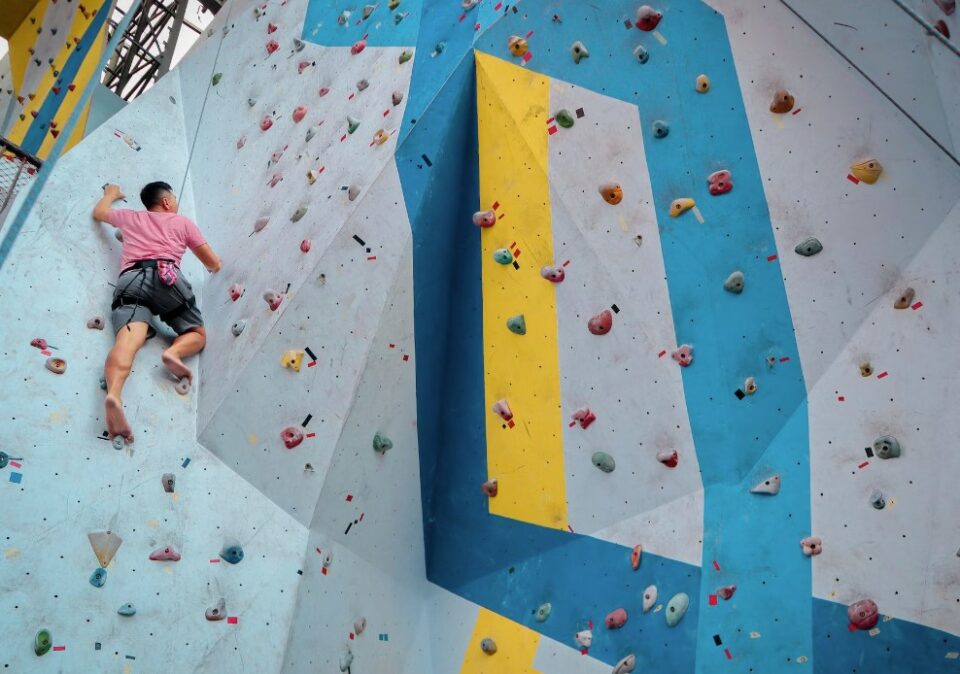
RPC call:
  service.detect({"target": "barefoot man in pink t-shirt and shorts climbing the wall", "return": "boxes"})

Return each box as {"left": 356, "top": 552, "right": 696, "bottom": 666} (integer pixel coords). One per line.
{"left": 93, "top": 182, "right": 220, "bottom": 444}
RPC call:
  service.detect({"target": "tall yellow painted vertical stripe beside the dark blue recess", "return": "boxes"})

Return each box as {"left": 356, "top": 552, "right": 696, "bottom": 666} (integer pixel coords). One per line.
{"left": 476, "top": 52, "right": 567, "bottom": 529}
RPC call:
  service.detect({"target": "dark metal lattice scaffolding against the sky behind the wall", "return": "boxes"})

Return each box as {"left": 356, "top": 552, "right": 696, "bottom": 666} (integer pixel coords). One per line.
{"left": 102, "top": 0, "right": 226, "bottom": 101}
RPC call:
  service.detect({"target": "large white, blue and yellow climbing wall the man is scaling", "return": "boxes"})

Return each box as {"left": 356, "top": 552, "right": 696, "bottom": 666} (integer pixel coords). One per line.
{"left": 0, "top": 0, "right": 960, "bottom": 674}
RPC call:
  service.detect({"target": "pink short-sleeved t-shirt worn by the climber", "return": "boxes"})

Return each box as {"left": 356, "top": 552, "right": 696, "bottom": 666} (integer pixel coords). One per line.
{"left": 107, "top": 208, "right": 207, "bottom": 271}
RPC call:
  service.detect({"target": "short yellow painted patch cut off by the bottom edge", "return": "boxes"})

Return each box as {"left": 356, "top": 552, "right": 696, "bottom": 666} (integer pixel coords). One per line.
{"left": 460, "top": 608, "right": 540, "bottom": 674}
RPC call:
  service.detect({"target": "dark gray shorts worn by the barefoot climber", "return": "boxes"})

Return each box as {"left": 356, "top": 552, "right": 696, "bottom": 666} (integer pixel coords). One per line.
{"left": 110, "top": 262, "right": 203, "bottom": 339}
